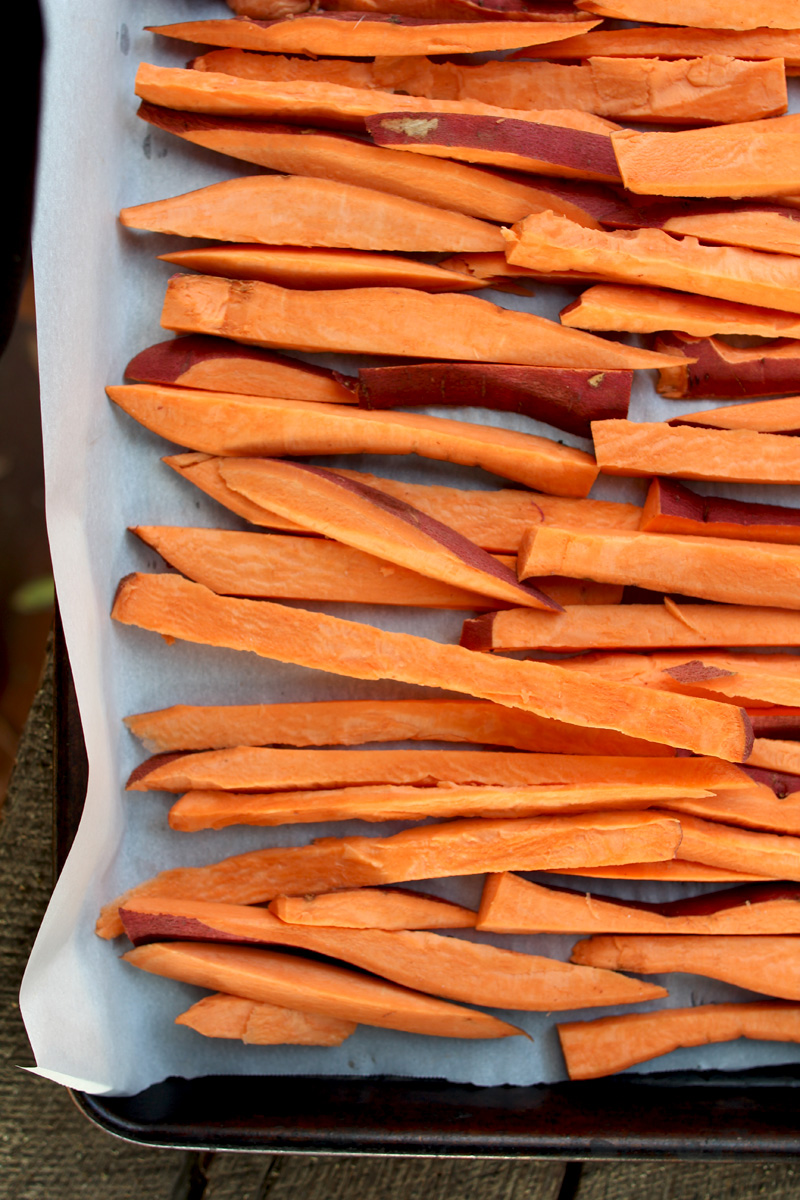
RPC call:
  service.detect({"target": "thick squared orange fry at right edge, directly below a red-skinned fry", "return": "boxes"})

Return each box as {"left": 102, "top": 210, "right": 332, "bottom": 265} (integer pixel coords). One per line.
{"left": 518, "top": 528, "right": 800, "bottom": 609}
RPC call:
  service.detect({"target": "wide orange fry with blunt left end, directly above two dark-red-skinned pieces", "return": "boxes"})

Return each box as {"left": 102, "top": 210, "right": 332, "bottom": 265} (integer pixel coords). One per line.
{"left": 162, "top": 274, "right": 674, "bottom": 371}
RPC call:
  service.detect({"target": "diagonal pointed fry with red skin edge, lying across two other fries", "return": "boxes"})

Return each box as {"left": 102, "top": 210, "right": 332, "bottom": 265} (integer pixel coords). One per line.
{"left": 215, "top": 458, "right": 561, "bottom": 612}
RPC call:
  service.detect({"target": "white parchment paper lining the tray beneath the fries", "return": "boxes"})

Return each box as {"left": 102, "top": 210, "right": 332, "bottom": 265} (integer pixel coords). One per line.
{"left": 20, "top": 0, "right": 800, "bottom": 1094}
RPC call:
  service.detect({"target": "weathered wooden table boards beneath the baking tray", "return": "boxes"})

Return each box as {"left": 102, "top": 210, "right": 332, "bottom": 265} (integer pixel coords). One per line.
{"left": 0, "top": 662, "right": 800, "bottom": 1200}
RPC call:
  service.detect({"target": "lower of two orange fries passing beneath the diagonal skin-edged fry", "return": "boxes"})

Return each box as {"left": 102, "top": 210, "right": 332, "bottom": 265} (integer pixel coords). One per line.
{"left": 131, "top": 526, "right": 525, "bottom": 608}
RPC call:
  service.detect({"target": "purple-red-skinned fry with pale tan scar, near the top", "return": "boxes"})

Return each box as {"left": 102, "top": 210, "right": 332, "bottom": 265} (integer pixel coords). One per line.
{"left": 366, "top": 113, "right": 621, "bottom": 184}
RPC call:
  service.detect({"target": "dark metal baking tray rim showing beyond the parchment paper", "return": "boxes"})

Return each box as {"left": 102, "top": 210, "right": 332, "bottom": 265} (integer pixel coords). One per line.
{"left": 54, "top": 622, "right": 800, "bottom": 1159}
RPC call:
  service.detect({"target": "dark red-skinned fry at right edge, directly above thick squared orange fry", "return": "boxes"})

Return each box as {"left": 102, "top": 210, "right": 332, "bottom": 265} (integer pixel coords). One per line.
{"left": 639, "top": 478, "right": 800, "bottom": 546}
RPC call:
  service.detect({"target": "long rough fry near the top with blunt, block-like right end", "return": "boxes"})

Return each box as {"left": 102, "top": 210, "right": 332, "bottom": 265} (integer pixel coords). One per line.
{"left": 192, "top": 50, "right": 787, "bottom": 125}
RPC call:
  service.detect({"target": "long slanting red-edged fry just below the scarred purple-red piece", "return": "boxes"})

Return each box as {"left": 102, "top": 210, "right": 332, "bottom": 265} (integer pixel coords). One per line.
{"left": 138, "top": 103, "right": 627, "bottom": 228}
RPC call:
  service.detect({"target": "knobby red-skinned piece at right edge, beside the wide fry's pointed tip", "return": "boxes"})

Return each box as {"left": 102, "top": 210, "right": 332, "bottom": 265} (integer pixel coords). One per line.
{"left": 654, "top": 332, "right": 800, "bottom": 400}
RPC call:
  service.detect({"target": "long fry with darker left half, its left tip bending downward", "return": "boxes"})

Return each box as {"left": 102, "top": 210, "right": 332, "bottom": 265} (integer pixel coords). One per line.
{"left": 96, "top": 812, "right": 680, "bottom": 940}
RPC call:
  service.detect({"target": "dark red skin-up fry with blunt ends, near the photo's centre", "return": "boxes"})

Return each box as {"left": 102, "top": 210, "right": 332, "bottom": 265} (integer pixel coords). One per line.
{"left": 359, "top": 362, "right": 633, "bottom": 438}
